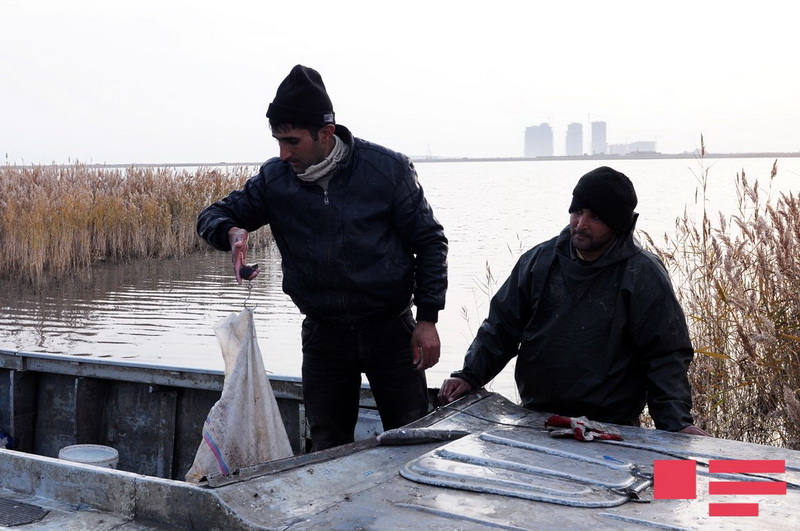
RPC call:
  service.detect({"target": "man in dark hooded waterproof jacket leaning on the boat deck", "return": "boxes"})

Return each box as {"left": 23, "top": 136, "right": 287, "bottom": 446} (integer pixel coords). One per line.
{"left": 440, "top": 167, "right": 708, "bottom": 435}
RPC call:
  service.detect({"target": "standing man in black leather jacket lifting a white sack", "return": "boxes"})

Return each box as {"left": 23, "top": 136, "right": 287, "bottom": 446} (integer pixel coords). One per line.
{"left": 197, "top": 65, "right": 448, "bottom": 450}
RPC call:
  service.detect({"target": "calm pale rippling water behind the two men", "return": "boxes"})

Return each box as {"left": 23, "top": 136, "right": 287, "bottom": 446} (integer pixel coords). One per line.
{"left": 0, "top": 158, "right": 800, "bottom": 399}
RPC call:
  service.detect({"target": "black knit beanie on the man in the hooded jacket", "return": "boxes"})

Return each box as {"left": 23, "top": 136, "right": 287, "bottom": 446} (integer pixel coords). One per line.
{"left": 569, "top": 166, "right": 638, "bottom": 232}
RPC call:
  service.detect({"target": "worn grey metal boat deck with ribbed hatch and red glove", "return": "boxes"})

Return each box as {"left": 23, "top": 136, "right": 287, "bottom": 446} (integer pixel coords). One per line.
{"left": 0, "top": 391, "right": 800, "bottom": 530}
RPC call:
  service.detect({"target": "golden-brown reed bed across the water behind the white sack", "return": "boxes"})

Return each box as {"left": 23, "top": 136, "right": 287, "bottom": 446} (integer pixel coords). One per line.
{"left": 0, "top": 163, "right": 270, "bottom": 284}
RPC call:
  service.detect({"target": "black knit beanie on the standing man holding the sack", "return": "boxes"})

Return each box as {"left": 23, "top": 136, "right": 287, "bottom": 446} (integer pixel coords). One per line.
{"left": 267, "top": 65, "right": 335, "bottom": 126}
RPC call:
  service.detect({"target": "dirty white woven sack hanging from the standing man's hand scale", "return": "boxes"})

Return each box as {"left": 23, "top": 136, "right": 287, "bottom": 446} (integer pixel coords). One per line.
{"left": 186, "top": 310, "right": 292, "bottom": 483}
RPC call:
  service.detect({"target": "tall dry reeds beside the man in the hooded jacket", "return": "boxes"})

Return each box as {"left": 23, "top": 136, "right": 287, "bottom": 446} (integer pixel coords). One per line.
{"left": 646, "top": 138, "right": 800, "bottom": 449}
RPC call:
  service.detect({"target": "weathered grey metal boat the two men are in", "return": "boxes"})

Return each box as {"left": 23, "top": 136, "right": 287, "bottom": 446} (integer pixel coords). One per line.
{"left": 0, "top": 351, "right": 800, "bottom": 530}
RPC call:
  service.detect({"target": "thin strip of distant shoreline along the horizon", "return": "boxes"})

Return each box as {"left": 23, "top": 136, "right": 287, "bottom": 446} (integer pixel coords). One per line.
{"left": 6, "top": 151, "right": 800, "bottom": 168}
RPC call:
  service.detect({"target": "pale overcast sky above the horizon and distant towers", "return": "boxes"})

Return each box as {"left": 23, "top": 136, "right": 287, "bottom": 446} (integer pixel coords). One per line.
{"left": 0, "top": 0, "right": 800, "bottom": 164}
